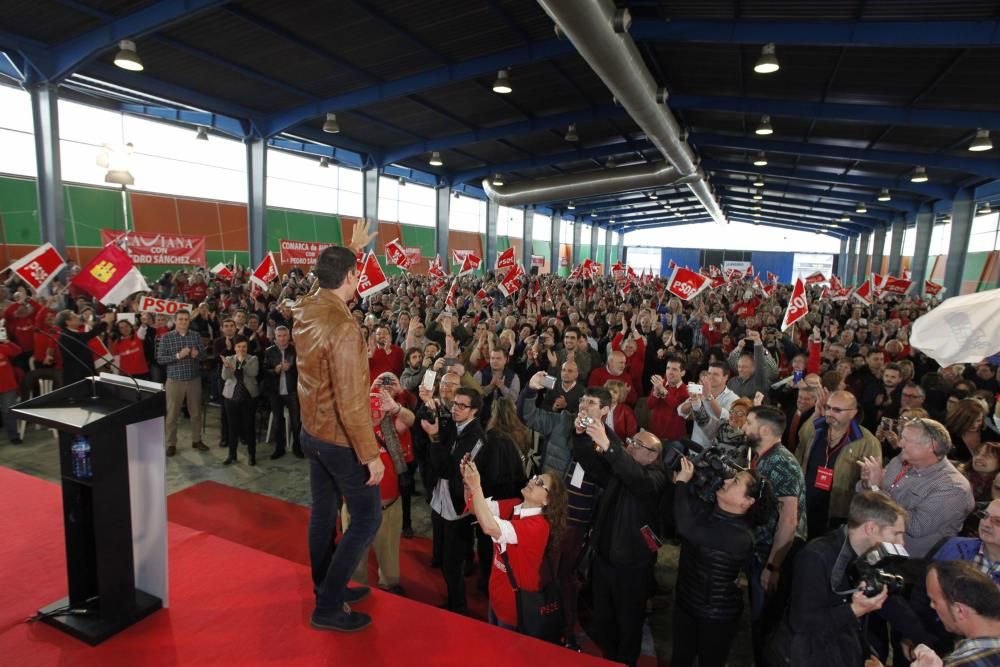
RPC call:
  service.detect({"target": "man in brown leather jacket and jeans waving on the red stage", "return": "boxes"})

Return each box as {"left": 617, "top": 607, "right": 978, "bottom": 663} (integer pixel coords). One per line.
{"left": 292, "top": 230, "right": 384, "bottom": 632}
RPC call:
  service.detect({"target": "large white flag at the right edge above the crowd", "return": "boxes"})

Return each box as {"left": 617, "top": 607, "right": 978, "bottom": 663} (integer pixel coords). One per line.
{"left": 910, "top": 289, "right": 1000, "bottom": 366}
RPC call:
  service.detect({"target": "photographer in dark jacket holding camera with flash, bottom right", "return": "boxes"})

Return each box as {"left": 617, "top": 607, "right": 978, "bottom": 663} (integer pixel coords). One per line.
{"left": 788, "top": 492, "right": 929, "bottom": 667}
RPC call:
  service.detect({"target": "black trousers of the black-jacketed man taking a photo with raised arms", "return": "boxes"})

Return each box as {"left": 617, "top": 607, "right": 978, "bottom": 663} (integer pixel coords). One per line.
{"left": 590, "top": 554, "right": 653, "bottom": 665}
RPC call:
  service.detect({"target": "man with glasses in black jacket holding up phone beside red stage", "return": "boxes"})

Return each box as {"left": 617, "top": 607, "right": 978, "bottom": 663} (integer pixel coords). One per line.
{"left": 420, "top": 387, "right": 486, "bottom": 614}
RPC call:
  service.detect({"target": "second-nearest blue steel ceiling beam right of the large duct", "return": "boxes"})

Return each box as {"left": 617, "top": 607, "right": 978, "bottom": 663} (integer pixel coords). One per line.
{"left": 667, "top": 95, "right": 1000, "bottom": 130}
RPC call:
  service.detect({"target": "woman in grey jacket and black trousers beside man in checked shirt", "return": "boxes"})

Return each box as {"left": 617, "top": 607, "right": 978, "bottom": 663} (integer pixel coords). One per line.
{"left": 222, "top": 336, "right": 259, "bottom": 466}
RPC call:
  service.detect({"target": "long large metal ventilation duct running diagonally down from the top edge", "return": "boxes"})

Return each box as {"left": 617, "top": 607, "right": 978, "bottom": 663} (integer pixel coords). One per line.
{"left": 538, "top": 0, "right": 726, "bottom": 223}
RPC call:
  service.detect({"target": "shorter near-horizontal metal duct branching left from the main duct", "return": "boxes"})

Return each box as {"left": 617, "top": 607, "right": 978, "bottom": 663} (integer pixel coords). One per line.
{"left": 483, "top": 162, "right": 681, "bottom": 206}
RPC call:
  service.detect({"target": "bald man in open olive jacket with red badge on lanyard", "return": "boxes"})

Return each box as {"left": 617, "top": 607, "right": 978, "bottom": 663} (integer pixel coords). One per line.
{"left": 795, "top": 391, "right": 882, "bottom": 539}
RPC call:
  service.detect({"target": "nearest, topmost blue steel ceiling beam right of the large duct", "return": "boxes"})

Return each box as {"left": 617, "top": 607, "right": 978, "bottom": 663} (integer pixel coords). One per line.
{"left": 629, "top": 20, "right": 1000, "bottom": 49}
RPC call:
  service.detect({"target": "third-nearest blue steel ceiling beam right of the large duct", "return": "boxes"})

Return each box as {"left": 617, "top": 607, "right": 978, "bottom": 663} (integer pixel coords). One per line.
{"left": 690, "top": 132, "right": 1000, "bottom": 178}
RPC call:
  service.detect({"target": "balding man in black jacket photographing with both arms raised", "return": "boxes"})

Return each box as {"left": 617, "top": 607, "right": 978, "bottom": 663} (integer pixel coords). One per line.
{"left": 573, "top": 420, "right": 667, "bottom": 665}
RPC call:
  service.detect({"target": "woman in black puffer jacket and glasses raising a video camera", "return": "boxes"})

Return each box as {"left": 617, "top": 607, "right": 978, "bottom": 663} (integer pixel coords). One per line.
{"left": 670, "top": 458, "right": 774, "bottom": 667}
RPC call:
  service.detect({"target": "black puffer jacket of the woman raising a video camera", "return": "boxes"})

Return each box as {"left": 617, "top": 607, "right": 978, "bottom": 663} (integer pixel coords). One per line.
{"left": 674, "top": 483, "right": 753, "bottom": 621}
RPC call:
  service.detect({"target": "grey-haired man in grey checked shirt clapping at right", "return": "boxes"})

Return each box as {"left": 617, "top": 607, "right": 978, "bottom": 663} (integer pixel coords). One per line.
{"left": 857, "top": 419, "right": 975, "bottom": 558}
